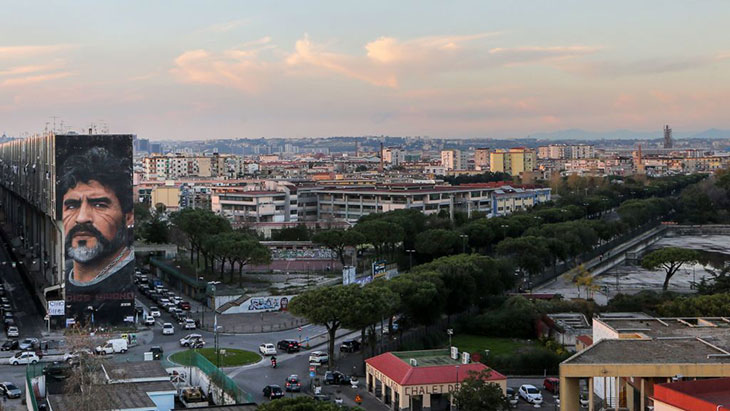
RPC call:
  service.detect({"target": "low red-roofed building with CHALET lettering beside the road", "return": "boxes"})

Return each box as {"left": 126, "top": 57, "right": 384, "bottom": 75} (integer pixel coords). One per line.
{"left": 365, "top": 350, "right": 507, "bottom": 411}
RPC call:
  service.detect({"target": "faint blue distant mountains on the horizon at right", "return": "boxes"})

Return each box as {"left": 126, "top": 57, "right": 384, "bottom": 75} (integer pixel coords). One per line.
{"left": 528, "top": 128, "right": 730, "bottom": 140}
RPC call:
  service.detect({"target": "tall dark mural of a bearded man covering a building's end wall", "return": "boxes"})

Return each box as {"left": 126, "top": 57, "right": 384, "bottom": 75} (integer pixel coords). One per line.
{"left": 55, "top": 135, "right": 134, "bottom": 325}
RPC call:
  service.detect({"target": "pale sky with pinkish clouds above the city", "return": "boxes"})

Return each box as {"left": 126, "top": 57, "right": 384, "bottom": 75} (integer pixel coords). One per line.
{"left": 0, "top": 0, "right": 730, "bottom": 139}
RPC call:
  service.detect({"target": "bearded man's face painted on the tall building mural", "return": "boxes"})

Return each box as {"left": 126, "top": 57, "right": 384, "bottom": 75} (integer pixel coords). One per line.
{"left": 62, "top": 180, "right": 134, "bottom": 264}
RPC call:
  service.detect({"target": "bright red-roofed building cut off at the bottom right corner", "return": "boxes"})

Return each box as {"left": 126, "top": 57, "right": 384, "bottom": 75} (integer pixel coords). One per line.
{"left": 653, "top": 378, "right": 730, "bottom": 411}
